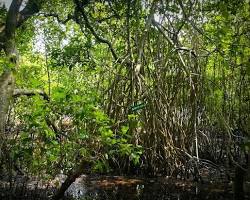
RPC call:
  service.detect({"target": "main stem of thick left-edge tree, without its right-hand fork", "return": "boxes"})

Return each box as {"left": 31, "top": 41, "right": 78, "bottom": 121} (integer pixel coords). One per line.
{"left": 0, "top": 0, "right": 22, "bottom": 156}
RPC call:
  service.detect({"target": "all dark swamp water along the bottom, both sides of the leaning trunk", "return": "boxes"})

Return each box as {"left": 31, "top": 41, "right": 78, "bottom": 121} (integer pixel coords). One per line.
{"left": 0, "top": 175, "right": 250, "bottom": 200}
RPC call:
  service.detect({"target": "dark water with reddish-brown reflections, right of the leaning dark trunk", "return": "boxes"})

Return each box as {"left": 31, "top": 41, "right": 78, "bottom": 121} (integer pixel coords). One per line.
{"left": 63, "top": 177, "right": 233, "bottom": 200}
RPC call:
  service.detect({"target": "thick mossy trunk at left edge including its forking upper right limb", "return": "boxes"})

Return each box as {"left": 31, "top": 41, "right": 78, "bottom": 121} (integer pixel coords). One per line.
{"left": 0, "top": 0, "right": 41, "bottom": 167}
